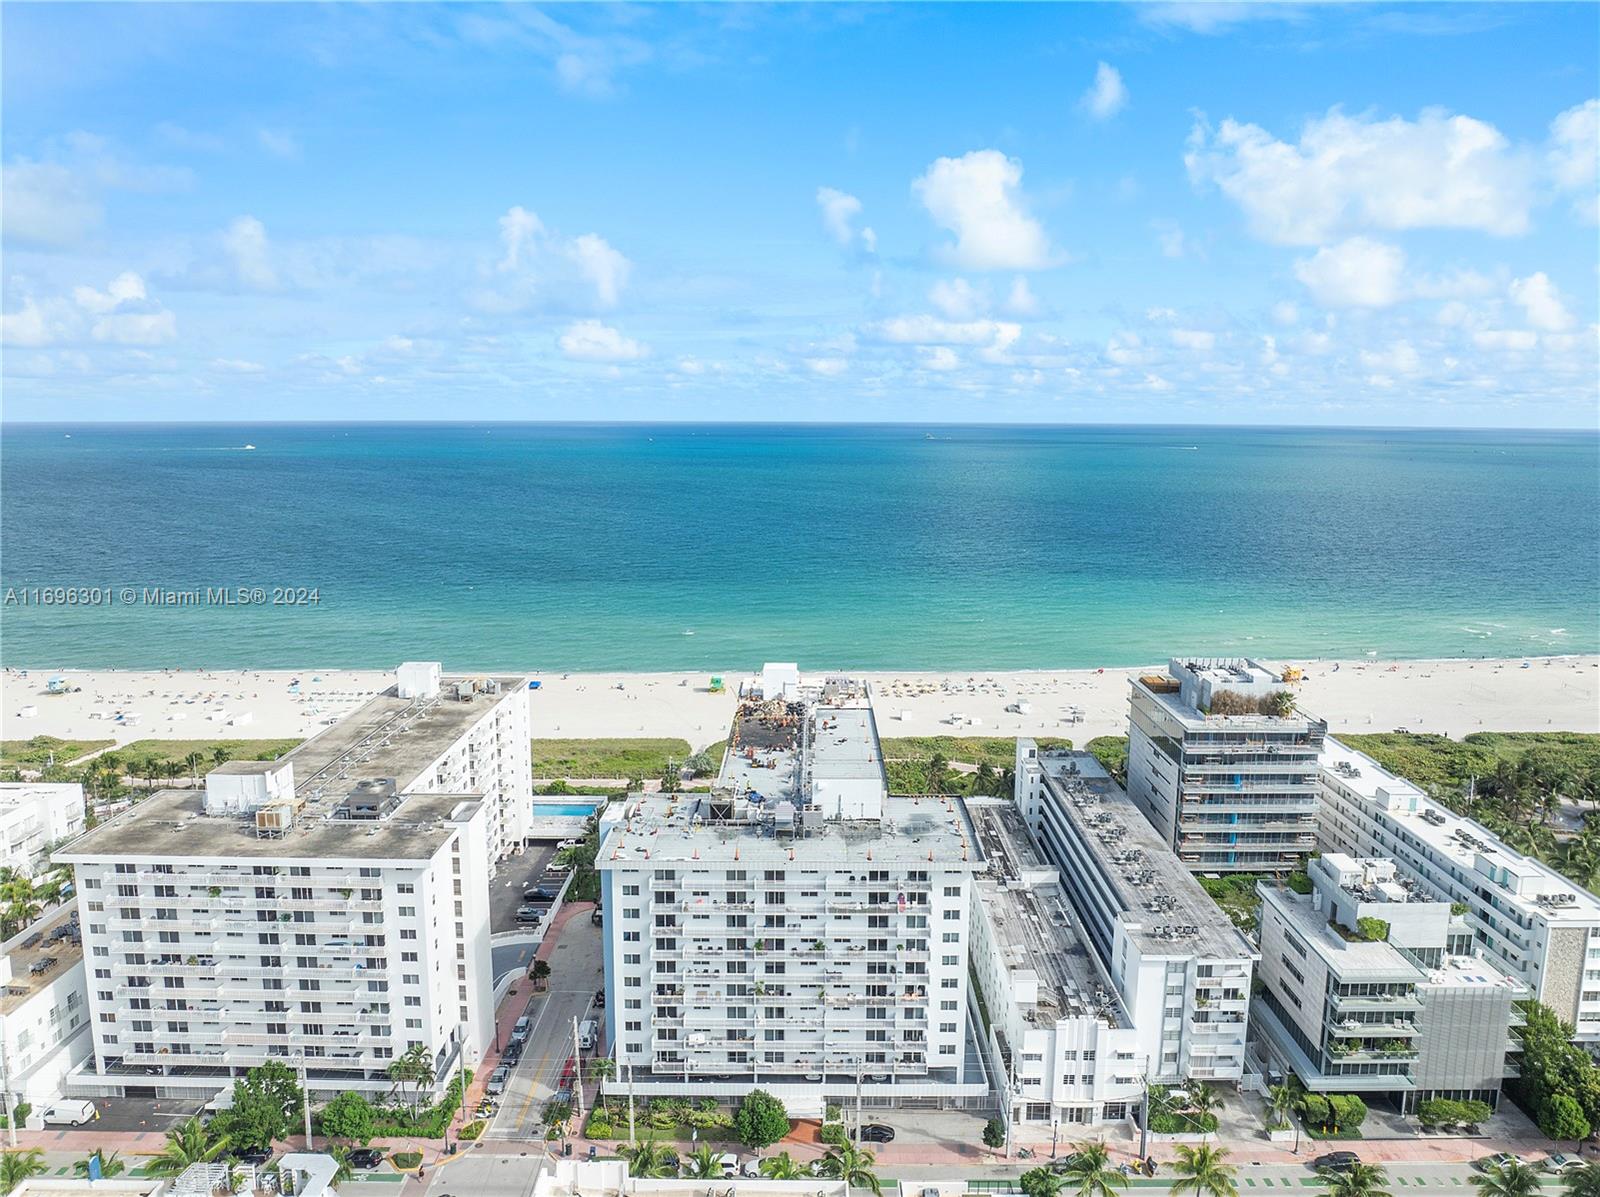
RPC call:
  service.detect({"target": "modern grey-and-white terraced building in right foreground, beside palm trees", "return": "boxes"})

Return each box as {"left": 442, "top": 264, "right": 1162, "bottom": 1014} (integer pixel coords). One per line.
{"left": 1256, "top": 853, "right": 1530, "bottom": 1112}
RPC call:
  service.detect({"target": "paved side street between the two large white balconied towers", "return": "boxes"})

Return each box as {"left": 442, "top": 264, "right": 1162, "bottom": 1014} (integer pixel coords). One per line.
{"left": 485, "top": 917, "right": 605, "bottom": 1146}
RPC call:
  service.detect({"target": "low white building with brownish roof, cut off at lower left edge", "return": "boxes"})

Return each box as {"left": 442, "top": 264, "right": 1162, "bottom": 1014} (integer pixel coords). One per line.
{"left": 0, "top": 906, "right": 91, "bottom": 1114}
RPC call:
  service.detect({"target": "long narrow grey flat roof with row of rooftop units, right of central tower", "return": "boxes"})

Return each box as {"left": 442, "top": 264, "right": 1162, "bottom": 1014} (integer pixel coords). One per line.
{"left": 1038, "top": 752, "right": 1256, "bottom": 959}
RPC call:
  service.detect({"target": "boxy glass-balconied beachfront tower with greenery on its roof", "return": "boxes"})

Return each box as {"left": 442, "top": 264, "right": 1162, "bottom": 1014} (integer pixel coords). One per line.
{"left": 1128, "top": 658, "right": 1328, "bottom": 872}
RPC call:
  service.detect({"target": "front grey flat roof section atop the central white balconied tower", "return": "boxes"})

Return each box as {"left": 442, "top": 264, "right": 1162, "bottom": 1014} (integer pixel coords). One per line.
{"left": 595, "top": 794, "right": 976, "bottom": 871}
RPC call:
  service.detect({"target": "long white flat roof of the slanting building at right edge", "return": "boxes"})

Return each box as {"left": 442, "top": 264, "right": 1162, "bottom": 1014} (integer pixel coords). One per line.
{"left": 1320, "top": 736, "right": 1600, "bottom": 923}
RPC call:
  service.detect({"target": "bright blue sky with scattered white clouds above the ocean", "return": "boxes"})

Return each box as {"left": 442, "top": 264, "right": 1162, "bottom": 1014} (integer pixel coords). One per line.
{"left": 0, "top": 3, "right": 1600, "bottom": 429}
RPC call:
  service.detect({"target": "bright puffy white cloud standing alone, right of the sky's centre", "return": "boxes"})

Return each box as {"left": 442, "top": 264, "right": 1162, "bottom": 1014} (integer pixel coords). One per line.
{"left": 912, "top": 150, "right": 1056, "bottom": 270}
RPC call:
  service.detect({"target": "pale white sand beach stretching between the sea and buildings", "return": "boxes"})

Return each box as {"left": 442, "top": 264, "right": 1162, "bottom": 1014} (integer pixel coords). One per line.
{"left": 0, "top": 656, "right": 1600, "bottom": 758}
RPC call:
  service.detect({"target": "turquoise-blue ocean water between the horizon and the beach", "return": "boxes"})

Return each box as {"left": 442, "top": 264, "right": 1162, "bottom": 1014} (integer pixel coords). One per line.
{"left": 0, "top": 424, "right": 1600, "bottom": 669}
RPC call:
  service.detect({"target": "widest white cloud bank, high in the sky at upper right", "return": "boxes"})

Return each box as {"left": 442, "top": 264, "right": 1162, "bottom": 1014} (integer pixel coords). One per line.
{"left": 1184, "top": 109, "right": 1534, "bottom": 245}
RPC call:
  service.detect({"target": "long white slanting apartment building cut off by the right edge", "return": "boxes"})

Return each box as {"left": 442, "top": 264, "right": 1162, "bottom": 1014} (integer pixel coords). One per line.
{"left": 1320, "top": 739, "right": 1600, "bottom": 1045}
